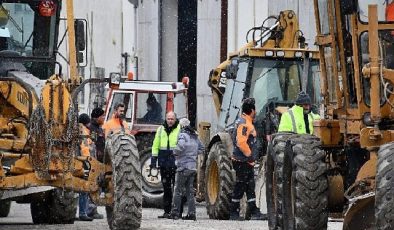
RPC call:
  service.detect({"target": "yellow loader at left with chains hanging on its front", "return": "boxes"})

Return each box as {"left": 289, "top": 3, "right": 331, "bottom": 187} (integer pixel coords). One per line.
{"left": 0, "top": 0, "right": 142, "bottom": 229}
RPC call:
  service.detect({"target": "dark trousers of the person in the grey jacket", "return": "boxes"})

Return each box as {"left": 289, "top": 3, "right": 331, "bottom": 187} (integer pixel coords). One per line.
{"left": 171, "top": 169, "right": 196, "bottom": 216}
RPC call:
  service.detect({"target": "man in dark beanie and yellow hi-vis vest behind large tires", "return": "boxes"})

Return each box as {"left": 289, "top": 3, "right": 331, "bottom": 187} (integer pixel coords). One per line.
{"left": 278, "top": 91, "right": 320, "bottom": 134}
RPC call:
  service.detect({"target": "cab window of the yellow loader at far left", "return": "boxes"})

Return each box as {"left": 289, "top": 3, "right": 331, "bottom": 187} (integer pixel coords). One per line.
{"left": 0, "top": 1, "right": 56, "bottom": 57}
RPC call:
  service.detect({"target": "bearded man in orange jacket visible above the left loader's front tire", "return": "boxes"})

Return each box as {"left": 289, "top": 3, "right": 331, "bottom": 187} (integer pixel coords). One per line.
{"left": 103, "top": 103, "right": 129, "bottom": 137}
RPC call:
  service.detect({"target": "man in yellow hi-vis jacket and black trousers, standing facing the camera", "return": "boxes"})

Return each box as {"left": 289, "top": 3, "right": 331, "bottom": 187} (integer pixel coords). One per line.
{"left": 150, "top": 112, "right": 180, "bottom": 218}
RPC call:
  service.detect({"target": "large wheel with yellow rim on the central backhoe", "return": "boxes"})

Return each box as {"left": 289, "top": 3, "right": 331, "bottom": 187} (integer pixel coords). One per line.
{"left": 205, "top": 141, "right": 235, "bottom": 220}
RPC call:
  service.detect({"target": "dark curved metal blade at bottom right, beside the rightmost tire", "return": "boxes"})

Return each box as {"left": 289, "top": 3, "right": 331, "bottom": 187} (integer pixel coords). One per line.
{"left": 343, "top": 192, "right": 375, "bottom": 230}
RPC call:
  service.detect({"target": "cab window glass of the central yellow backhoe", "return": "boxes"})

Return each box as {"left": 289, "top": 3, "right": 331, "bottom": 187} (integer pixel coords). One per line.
{"left": 250, "top": 59, "right": 320, "bottom": 111}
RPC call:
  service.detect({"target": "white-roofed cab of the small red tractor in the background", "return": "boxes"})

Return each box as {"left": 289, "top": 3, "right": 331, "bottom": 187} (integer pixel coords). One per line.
{"left": 105, "top": 74, "right": 188, "bottom": 134}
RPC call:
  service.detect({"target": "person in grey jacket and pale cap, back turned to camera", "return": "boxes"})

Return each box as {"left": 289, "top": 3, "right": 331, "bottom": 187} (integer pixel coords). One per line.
{"left": 171, "top": 118, "right": 204, "bottom": 220}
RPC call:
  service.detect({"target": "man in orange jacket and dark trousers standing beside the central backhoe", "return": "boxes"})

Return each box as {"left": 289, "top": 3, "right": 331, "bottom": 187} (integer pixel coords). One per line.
{"left": 230, "top": 98, "right": 263, "bottom": 220}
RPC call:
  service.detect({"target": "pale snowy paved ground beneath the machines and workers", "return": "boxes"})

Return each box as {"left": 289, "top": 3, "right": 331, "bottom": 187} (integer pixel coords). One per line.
{"left": 0, "top": 203, "right": 342, "bottom": 230}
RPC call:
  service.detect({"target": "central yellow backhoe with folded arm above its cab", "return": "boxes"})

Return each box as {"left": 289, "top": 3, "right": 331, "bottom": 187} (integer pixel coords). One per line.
{"left": 197, "top": 10, "right": 320, "bottom": 219}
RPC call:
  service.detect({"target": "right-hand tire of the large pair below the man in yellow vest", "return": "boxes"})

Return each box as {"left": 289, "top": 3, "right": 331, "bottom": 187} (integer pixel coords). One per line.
{"left": 282, "top": 134, "right": 328, "bottom": 230}
